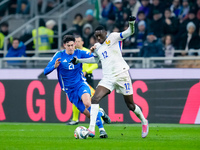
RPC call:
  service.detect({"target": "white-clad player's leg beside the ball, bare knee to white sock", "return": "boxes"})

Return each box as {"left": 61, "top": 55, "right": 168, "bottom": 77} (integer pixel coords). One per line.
{"left": 88, "top": 86, "right": 110, "bottom": 133}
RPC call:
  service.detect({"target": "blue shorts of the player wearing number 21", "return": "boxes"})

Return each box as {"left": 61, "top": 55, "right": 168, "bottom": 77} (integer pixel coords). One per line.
{"left": 67, "top": 82, "right": 91, "bottom": 113}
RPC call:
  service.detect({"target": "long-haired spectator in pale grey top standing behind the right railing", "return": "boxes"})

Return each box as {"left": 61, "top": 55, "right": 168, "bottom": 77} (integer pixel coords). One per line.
{"left": 163, "top": 34, "right": 175, "bottom": 67}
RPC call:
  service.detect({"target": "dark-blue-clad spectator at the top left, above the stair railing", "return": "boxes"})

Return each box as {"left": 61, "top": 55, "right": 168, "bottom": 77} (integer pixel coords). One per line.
{"left": 16, "top": 0, "right": 30, "bottom": 14}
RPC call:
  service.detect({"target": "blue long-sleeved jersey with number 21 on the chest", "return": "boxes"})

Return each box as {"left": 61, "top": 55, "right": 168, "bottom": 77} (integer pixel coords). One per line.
{"left": 44, "top": 49, "right": 93, "bottom": 93}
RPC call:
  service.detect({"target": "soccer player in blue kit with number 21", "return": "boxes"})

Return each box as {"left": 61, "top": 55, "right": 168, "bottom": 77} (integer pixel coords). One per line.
{"left": 44, "top": 35, "right": 110, "bottom": 138}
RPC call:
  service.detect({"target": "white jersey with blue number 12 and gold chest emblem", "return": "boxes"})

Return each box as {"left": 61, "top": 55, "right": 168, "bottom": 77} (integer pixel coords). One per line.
{"left": 94, "top": 32, "right": 129, "bottom": 77}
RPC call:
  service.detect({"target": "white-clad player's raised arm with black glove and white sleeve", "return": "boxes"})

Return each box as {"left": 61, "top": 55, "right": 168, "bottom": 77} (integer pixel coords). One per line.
{"left": 122, "top": 16, "right": 136, "bottom": 39}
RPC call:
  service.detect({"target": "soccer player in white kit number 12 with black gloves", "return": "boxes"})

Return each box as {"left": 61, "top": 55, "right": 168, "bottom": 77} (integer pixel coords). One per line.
{"left": 72, "top": 16, "right": 149, "bottom": 138}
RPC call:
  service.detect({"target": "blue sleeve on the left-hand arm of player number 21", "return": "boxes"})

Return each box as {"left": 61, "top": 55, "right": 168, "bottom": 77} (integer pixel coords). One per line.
{"left": 44, "top": 52, "right": 60, "bottom": 75}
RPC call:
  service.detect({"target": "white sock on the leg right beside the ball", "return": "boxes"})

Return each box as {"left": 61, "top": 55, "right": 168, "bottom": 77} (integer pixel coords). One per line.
{"left": 89, "top": 104, "right": 99, "bottom": 132}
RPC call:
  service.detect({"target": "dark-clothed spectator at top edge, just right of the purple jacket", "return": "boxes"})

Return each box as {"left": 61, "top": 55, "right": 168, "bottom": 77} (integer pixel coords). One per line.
{"left": 148, "top": 0, "right": 165, "bottom": 19}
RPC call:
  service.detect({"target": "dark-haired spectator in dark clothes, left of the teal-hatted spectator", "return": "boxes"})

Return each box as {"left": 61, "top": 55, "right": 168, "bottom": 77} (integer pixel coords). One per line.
{"left": 73, "top": 13, "right": 83, "bottom": 36}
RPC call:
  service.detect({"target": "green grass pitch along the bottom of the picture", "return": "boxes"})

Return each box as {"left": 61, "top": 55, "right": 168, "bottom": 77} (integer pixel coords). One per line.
{"left": 0, "top": 122, "right": 200, "bottom": 150}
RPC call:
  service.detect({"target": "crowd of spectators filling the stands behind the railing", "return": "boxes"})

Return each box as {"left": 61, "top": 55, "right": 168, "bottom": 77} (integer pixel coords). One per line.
{"left": 0, "top": 0, "right": 200, "bottom": 65}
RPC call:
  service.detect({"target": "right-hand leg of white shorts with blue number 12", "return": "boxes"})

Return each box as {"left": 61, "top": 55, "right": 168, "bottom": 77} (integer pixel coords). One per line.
{"left": 115, "top": 71, "right": 133, "bottom": 95}
